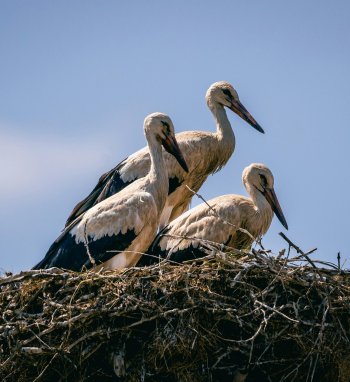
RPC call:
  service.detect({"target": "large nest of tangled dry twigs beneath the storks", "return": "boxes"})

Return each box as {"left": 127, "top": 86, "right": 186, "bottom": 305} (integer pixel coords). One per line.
{"left": 0, "top": 251, "right": 350, "bottom": 382}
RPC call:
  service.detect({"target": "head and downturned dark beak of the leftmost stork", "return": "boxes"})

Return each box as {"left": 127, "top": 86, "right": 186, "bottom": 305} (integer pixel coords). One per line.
{"left": 144, "top": 113, "right": 188, "bottom": 172}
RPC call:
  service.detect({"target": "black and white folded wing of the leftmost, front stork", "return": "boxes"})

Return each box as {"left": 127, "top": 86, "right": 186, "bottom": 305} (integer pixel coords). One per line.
{"left": 34, "top": 190, "right": 157, "bottom": 271}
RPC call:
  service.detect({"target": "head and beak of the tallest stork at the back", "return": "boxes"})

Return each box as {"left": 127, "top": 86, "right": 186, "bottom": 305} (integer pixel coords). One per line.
{"left": 205, "top": 81, "right": 264, "bottom": 133}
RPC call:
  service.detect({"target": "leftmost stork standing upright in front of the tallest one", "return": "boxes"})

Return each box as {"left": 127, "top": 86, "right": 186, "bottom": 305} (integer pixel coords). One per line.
{"left": 34, "top": 113, "right": 188, "bottom": 271}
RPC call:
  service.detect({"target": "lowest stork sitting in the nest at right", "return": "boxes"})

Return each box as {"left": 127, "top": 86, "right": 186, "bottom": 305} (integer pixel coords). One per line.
{"left": 138, "top": 163, "right": 288, "bottom": 265}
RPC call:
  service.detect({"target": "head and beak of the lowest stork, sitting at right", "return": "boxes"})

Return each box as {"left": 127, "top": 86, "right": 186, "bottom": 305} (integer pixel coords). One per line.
{"left": 242, "top": 163, "right": 288, "bottom": 229}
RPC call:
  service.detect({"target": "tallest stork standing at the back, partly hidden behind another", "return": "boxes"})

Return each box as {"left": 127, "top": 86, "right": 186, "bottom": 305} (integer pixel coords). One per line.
{"left": 66, "top": 81, "right": 264, "bottom": 228}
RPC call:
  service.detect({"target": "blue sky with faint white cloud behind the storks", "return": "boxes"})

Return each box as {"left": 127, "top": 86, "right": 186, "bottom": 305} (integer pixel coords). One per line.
{"left": 0, "top": 0, "right": 350, "bottom": 272}
